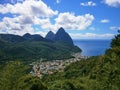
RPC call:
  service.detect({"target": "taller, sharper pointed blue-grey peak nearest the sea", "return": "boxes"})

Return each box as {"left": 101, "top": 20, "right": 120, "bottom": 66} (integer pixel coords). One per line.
{"left": 54, "top": 27, "right": 73, "bottom": 45}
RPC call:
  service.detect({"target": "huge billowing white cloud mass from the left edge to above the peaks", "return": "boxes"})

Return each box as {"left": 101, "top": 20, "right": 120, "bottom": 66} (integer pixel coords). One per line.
{"left": 0, "top": 0, "right": 94, "bottom": 36}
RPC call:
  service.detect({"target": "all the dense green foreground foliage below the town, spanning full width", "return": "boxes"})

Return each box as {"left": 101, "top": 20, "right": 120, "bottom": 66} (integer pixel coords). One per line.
{"left": 0, "top": 30, "right": 120, "bottom": 90}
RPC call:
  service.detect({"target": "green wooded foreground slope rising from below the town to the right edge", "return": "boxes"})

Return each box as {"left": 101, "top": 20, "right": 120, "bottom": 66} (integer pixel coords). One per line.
{"left": 43, "top": 30, "right": 120, "bottom": 90}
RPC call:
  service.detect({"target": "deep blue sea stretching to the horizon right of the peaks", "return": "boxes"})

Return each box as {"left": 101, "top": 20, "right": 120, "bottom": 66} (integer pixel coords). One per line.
{"left": 74, "top": 40, "right": 111, "bottom": 56}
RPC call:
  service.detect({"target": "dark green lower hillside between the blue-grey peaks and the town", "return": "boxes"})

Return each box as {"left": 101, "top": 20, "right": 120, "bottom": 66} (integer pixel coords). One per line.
{"left": 0, "top": 41, "right": 81, "bottom": 61}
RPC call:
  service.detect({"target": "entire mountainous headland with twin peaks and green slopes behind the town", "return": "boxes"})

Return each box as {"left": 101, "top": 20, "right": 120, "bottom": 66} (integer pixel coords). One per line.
{"left": 0, "top": 27, "right": 82, "bottom": 61}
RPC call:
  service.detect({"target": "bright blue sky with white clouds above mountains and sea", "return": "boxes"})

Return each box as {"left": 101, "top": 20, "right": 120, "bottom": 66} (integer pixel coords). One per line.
{"left": 0, "top": 0, "right": 120, "bottom": 39}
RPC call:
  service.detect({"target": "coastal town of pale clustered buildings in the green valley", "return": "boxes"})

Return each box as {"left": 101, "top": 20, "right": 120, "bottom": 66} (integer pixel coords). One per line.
{"left": 30, "top": 53, "right": 87, "bottom": 78}
